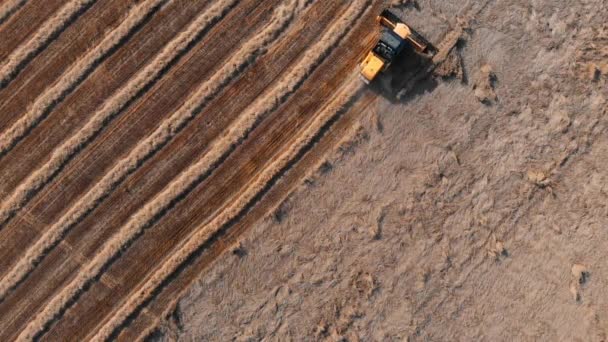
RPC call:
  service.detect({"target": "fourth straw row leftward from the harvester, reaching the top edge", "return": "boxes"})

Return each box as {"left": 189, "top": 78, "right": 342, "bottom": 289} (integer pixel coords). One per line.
{"left": 0, "top": 0, "right": 238, "bottom": 230}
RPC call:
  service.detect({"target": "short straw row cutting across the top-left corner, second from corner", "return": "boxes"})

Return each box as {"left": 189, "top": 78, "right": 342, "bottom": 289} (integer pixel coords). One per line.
{"left": 0, "top": 0, "right": 96, "bottom": 88}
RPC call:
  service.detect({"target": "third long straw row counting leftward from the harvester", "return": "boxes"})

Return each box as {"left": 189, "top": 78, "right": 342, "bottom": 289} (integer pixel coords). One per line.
{"left": 0, "top": 0, "right": 296, "bottom": 316}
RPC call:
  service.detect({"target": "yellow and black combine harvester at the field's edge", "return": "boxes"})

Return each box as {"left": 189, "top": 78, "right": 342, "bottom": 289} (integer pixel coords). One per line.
{"left": 361, "top": 9, "right": 437, "bottom": 83}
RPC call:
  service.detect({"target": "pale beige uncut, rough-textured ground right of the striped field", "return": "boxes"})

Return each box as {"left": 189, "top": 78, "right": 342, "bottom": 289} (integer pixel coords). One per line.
{"left": 152, "top": 0, "right": 608, "bottom": 341}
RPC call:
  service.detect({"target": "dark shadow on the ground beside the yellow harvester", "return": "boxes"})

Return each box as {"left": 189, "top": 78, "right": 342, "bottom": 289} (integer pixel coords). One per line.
{"left": 370, "top": 44, "right": 439, "bottom": 104}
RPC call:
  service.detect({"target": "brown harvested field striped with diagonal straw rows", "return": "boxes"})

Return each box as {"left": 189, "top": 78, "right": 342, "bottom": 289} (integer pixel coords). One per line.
{"left": 0, "top": 0, "right": 380, "bottom": 340}
